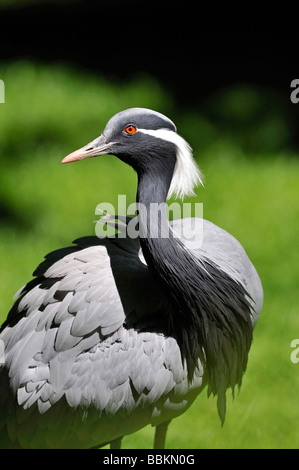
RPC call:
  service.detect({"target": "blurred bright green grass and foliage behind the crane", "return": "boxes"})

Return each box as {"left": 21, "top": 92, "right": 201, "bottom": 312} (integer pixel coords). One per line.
{"left": 0, "top": 61, "right": 299, "bottom": 449}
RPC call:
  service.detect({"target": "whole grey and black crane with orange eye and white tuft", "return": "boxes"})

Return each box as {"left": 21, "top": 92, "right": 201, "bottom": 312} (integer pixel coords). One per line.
{"left": 0, "top": 108, "right": 263, "bottom": 448}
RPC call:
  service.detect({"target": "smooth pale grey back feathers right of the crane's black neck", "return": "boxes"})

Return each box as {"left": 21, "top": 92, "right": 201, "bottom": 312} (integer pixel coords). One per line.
{"left": 172, "top": 218, "right": 263, "bottom": 325}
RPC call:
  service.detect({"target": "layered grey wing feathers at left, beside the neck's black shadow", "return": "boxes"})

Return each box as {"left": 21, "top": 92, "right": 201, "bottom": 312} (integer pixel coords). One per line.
{"left": 0, "top": 241, "right": 125, "bottom": 412}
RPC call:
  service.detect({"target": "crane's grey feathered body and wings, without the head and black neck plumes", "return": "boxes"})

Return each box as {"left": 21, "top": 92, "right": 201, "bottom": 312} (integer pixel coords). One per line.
{"left": 0, "top": 219, "right": 263, "bottom": 448}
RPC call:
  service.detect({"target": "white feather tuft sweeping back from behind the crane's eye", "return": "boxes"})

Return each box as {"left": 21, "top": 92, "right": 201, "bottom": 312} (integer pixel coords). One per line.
{"left": 139, "top": 129, "right": 203, "bottom": 199}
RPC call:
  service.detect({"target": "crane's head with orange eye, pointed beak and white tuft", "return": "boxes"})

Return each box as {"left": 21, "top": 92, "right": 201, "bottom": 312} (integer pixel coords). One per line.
{"left": 62, "top": 108, "right": 202, "bottom": 198}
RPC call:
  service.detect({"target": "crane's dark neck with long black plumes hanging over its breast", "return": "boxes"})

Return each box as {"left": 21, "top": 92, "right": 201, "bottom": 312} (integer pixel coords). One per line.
{"left": 137, "top": 164, "right": 252, "bottom": 423}
